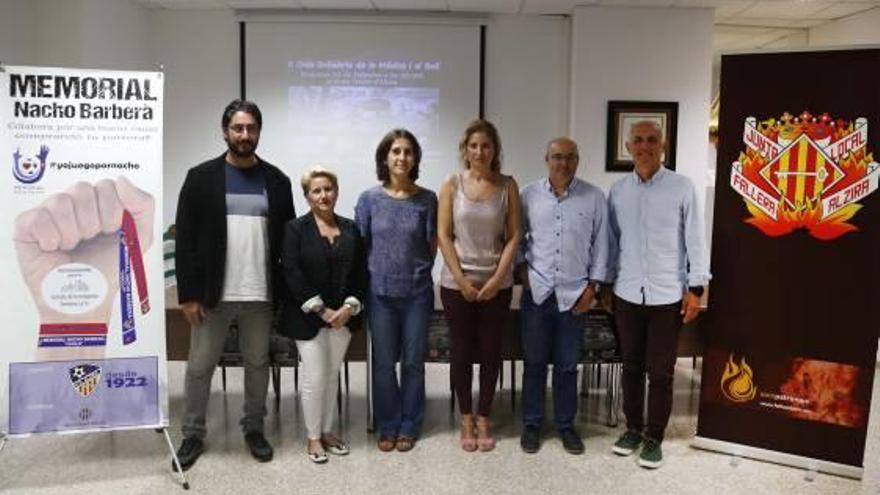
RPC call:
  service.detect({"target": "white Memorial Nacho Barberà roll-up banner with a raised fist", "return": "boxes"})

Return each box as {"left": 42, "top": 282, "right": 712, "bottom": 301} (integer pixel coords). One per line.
{"left": 0, "top": 66, "right": 168, "bottom": 437}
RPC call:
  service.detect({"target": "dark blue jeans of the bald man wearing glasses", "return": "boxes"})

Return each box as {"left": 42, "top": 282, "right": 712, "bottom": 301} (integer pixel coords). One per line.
{"left": 520, "top": 290, "right": 586, "bottom": 431}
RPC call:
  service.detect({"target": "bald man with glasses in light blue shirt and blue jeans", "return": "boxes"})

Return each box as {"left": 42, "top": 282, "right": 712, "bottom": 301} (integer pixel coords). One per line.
{"left": 518, "top": 138, "right": 609, "bottom": 454}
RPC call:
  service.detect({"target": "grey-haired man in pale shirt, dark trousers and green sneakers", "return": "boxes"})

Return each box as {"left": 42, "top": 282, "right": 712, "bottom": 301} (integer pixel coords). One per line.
{"left": 608, "top": 121, "right": 710, "bottom": 468}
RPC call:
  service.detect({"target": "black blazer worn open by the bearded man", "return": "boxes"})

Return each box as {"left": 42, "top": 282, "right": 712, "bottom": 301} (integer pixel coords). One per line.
{"left": 175, "top": 153, "right": 296, "bottom": 308}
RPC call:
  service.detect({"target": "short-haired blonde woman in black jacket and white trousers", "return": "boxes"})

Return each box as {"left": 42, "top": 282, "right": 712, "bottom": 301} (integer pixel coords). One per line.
{"left": 279, "top": 167, "right": 367, "bottom": 464}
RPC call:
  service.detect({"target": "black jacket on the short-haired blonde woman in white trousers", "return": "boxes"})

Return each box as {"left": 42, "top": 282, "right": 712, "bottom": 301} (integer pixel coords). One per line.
{"left": 278, "top": 212, "right": 367, "bottom": 340}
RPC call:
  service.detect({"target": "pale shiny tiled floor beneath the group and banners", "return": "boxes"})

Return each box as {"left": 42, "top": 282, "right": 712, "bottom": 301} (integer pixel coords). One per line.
{"left": 0, "top": 360, "right": 880, "bottom": 495}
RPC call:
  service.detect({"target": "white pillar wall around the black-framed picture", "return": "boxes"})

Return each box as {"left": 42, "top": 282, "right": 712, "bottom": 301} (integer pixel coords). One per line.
{"left": 571, "top": 7, "right": 713, "bottom": 204}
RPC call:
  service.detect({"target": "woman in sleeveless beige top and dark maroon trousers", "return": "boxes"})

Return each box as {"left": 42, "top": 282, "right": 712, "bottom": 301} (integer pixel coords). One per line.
{"left": 437, "top": 120, "right": 521, "bottom": 452}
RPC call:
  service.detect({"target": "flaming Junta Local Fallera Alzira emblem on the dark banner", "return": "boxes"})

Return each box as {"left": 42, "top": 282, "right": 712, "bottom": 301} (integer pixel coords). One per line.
{"left": 730, "top": 112, "right": 880, "bottom": 241}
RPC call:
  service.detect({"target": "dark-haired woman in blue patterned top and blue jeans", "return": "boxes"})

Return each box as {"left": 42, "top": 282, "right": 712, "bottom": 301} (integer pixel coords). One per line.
{"left": 355, "top": 129, "right": 437, "bottom": 452}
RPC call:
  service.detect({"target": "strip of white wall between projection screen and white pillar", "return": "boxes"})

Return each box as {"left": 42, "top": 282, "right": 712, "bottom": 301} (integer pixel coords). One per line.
{"left": 485, "top": 15, "right": 571, "bottom": 186}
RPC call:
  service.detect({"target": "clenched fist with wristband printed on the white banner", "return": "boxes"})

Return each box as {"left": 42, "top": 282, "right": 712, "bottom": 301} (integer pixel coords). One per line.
{"left": 13, "top": 177, "right": 155, "bottom": 359}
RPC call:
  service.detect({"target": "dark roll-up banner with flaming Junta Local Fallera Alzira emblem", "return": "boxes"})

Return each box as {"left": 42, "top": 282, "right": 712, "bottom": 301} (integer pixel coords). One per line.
{"left": 695, "top": 49, "right": 880, "bottom": 478}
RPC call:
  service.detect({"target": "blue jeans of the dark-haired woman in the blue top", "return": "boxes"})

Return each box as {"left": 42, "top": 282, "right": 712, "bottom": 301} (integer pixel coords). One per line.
{"left": 367, "top": 288, "right": 434, "bottom": 437}
